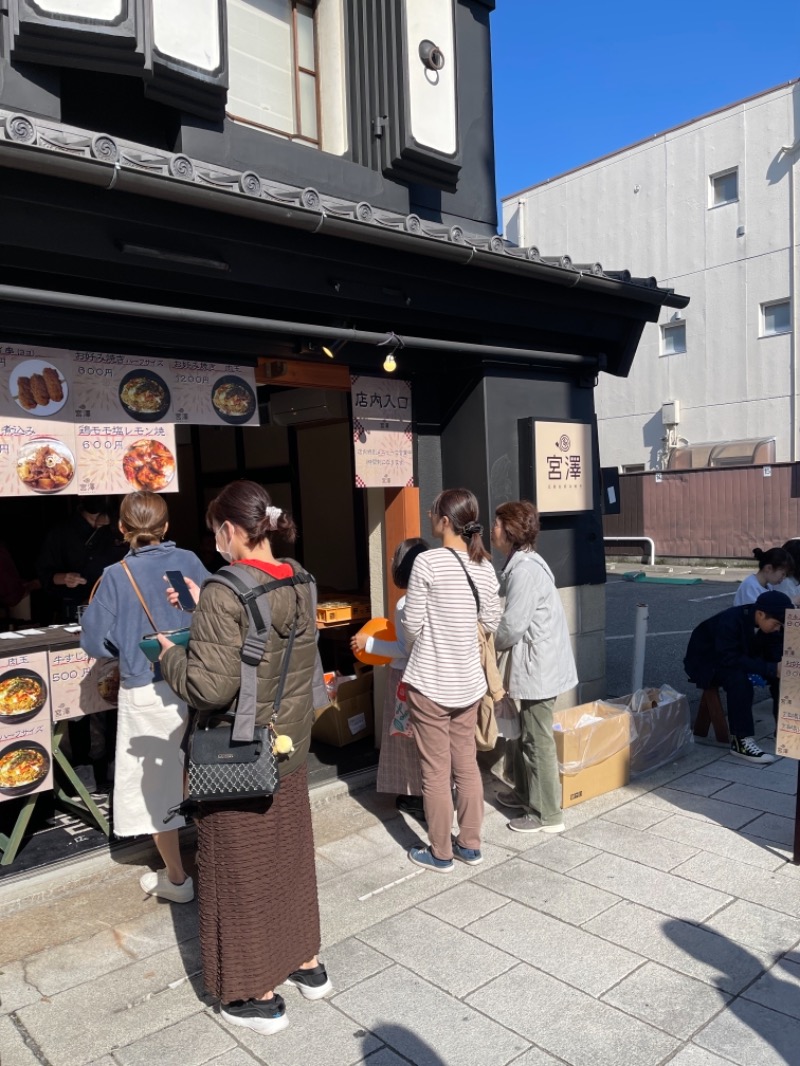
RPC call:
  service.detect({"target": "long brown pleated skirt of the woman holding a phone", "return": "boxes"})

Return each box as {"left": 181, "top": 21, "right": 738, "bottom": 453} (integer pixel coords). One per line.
{"left": 197, "top": 766, "right": 320, "bottom": 1003}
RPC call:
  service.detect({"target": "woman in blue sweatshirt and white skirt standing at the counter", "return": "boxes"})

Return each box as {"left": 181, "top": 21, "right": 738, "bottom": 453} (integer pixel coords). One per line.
{"left": 81, "top": 490, "right": 208, "bottom": 903}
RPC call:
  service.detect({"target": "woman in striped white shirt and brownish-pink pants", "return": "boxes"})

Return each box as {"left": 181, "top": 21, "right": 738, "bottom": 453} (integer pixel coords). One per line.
{"left": 403, "top": 488, "right": 501, "bottom": 873}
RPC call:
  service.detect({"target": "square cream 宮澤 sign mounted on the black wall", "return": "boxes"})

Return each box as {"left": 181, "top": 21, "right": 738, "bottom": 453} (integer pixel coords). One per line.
{"left": 533, "top": 420, "right": 594, "bottom": 515}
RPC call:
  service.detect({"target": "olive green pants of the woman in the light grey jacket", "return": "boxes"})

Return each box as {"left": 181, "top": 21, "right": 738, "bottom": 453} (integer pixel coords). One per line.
{"left": 512, "top": 697, "right": 563, "bottom": 825}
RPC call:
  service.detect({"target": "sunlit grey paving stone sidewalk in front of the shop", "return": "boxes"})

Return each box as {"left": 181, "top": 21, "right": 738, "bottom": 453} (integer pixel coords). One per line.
{"left": 0, "top": 705, "right": 800, "bottom": 1066}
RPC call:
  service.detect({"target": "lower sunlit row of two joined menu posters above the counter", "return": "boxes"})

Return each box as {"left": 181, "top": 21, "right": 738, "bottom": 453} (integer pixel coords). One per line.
{"left": 0, "top": 417, "right": 178, "bottom": 497}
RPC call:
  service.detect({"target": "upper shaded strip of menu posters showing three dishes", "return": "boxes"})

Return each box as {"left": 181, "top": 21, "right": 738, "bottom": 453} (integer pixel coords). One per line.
{"left": 0, "top": 344, "right": 259, "bottom": 425}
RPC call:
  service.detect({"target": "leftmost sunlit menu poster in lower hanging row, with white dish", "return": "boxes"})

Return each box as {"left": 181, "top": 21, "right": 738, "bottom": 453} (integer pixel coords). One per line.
{"left": 0, "top": 416, "right": 78, "bottom": 496}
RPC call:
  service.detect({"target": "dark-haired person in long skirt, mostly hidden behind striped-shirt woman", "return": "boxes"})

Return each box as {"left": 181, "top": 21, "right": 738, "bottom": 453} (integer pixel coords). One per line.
{"left": 350, "top": 537, "right": 429, "bottom": 818}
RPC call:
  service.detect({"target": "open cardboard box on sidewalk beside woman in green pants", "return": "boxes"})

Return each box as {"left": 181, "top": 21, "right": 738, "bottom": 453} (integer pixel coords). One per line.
{"left": 553, "top": 702, "right": 630, "bottom": 807}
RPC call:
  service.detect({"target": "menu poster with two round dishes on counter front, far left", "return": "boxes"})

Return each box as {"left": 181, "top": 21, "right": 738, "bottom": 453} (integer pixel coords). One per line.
{"left": 0, "top": 651, "right": 52, "bottom": 803}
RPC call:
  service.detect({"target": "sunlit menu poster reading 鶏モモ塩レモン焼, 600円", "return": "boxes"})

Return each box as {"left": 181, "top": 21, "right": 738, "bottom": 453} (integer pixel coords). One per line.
{"left": 76, "top": 423, "right": 178, "bottom": 495}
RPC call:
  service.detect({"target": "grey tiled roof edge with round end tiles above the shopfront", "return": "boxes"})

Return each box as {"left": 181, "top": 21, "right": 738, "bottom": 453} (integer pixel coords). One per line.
{"left": 0, "top": 109, "right": 688, "bottom": 307}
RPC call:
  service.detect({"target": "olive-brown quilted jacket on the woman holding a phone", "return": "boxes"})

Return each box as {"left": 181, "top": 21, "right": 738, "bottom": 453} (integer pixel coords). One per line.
{"left": 161, "top": 560, "right": 327, "bottom": 776}
